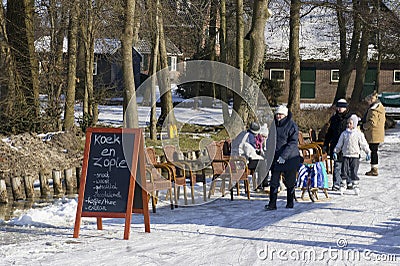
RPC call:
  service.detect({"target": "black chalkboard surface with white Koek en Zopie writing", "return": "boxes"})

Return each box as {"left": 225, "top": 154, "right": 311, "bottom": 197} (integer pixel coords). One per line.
{"left": 83, "top": 132, "right": 134, "bottom": 213}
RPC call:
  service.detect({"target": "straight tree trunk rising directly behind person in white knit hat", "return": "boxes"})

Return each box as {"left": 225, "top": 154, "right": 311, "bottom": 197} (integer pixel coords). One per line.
{"left": 288, "top": 0, "right": 301, "bottom": 116}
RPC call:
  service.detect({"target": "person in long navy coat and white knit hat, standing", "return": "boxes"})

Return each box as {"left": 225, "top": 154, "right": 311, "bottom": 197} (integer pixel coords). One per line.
{"left": 265, "top": 105, "right": 300, "bottom": 211}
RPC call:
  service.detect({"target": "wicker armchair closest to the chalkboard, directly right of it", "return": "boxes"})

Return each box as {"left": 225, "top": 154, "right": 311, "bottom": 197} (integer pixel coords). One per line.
{"left": 146, "top": 147, "right": 174, "bottom": 213}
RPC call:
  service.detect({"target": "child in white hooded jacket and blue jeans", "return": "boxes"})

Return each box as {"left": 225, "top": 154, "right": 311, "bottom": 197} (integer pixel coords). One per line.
{"left": 333, "top": 115, "right": 371, "bottom": 195}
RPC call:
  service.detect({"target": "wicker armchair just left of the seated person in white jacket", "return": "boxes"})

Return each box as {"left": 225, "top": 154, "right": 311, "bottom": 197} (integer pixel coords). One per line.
{"left": 206, "top": 141, "right": 250, "bottom": 200}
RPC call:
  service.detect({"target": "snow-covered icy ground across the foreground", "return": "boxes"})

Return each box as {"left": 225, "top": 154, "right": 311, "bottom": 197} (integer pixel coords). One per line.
{"left": 0, "top": 104, "right": 400, "bottom": 265}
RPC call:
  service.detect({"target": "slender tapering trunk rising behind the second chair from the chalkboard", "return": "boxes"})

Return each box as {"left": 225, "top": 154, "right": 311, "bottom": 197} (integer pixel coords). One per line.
{"left": 158, "top": 4, "right": 176, "bottom": 125}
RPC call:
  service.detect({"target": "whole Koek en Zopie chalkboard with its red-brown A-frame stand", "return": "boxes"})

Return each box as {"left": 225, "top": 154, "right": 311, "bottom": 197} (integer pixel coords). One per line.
{"left": 74, "top": 128, "right": 150, "bottom": 239}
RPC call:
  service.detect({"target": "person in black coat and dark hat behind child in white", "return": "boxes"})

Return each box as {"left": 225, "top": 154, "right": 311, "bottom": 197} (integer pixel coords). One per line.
{"left": 323, "top": 99, "right": 352, "bottom": 191}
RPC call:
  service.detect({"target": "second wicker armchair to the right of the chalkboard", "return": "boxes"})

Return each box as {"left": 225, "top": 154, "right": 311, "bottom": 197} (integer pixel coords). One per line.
{"left": 163, "top": 145, "right": 207, "bottom": 204}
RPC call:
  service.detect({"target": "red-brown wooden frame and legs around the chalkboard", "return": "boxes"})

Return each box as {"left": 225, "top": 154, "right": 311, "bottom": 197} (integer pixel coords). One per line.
{"left": 73, "top": 128, "right": 150, "bottom": 240}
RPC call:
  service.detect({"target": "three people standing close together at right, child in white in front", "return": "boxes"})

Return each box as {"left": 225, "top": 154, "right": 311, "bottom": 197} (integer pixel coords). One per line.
{"left": 323, "top": 92, "right": 386, "bottom": 193}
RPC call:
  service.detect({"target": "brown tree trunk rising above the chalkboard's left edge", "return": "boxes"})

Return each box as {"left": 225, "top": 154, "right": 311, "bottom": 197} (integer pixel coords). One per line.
{"left": 64, "top": 0, "right": 80, "bottom": 131}
